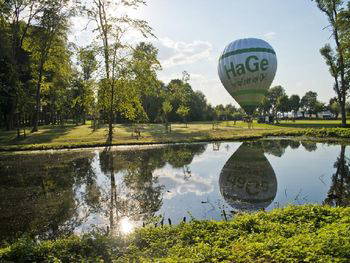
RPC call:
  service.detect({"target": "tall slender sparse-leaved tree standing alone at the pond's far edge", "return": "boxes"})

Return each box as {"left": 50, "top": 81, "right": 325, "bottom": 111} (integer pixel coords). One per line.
{"left": 84, "top": 0, "right": 153, "bottom": 143}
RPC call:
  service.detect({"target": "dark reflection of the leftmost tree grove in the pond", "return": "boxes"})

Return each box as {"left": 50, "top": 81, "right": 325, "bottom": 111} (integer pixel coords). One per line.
{"left": 0, "top": 152, "right": 95, "bottom": 244}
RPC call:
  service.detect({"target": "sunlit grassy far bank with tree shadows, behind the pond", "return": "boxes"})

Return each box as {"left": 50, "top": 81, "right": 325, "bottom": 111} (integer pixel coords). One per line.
{"left": 0, "top": 120, "right": 350, "bottom": 151}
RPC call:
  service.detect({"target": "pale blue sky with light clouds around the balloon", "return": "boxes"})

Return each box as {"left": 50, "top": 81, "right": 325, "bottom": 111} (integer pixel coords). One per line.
{"left": 70, "top": 0, "right": 335, "bottom": 105}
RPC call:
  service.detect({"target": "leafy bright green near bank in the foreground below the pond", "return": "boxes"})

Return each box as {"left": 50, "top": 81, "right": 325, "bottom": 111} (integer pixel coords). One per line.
{"left": 0, "top": 205, "right": 350, "bottom": 262}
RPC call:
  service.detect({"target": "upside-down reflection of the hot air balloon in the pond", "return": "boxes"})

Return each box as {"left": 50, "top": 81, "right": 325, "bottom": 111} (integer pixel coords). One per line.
{"left": 219, "top": 142, "right": 277, "bottom": 211}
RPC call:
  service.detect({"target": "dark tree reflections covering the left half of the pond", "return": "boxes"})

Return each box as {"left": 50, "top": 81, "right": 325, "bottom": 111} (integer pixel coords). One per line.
{"left": 0, "top": 144, "right": 206, "bottom": 245}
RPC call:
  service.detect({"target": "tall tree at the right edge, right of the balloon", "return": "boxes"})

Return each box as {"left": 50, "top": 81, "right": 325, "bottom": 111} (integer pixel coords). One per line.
{"left": 315, "top": 0, "right": 350, "bottom": 126}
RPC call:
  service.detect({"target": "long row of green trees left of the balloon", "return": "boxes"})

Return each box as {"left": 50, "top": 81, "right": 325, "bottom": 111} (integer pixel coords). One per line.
{"left": 0, "top": 0, "right": 243, "bottom": 141}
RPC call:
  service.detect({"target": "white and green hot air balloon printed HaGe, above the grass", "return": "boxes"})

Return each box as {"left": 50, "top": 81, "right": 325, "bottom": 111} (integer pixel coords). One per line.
{"left": 218, "top": 38, "right": 277, "bottom": 115}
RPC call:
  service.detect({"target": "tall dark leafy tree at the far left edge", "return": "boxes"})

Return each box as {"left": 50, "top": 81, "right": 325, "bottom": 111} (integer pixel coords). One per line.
{"left": 0, "top": 0, "right": 47, "bottom": 130}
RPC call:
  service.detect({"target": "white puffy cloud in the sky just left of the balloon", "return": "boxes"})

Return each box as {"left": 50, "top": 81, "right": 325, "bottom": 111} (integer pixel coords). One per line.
{"left": 156, "top": 37, "right": 212, "bottom": 68}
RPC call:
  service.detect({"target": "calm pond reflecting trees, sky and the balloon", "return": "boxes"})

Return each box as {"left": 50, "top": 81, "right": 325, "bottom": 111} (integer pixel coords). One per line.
{"left": 0, "top": 139, "right": 350, "bottom": 245}
